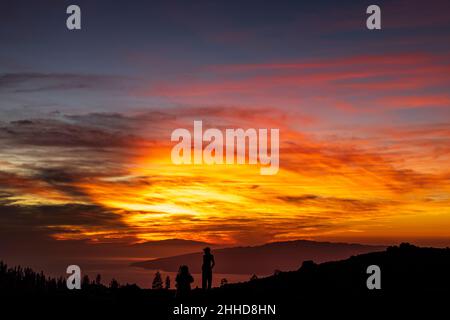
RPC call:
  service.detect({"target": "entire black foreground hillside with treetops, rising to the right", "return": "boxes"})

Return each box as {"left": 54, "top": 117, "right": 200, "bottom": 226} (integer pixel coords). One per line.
{"left": 0, "top": 244, "right": 450, "bottom": 319}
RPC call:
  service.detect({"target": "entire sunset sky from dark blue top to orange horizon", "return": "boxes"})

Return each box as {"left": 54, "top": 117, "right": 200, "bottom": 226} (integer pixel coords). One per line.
{"left": 0, "top": 1, "right": 450, "bottom": 262}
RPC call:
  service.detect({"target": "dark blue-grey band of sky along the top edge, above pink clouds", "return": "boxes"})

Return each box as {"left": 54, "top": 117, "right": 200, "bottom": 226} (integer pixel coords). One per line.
{"left": 0, "top": 0, "right": 450, "bottom": 77}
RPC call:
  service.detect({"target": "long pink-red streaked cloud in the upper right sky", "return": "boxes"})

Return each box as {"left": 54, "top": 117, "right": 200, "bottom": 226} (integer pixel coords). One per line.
{"left": 141, "top": 53, "right": 450, "bottom": 112}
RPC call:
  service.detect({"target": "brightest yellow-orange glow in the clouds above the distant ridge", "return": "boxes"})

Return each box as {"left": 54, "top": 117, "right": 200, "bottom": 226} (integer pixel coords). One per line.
{"left": 59, "top": 134, "right": 448, "bottom": 243}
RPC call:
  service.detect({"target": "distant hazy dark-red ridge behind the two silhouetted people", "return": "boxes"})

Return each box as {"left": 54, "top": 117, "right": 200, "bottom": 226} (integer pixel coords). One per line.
{"left": 132, "top": 240, "right": 386, "bottom": 275}
